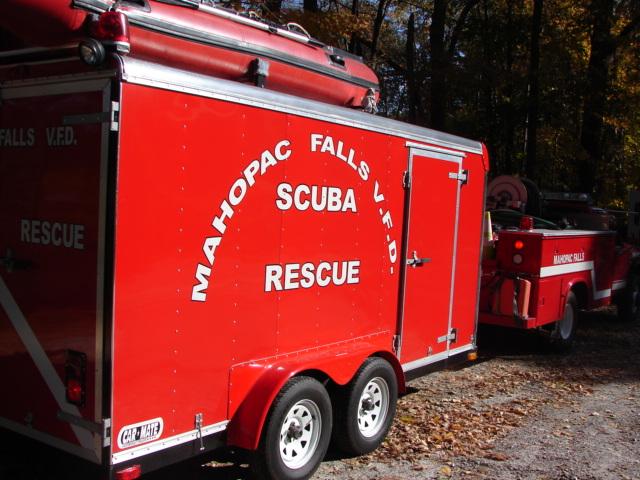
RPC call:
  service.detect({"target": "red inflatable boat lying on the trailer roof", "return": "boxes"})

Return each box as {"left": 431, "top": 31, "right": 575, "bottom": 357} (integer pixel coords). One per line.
{"left": 0, "top": 0, "right": 379, "bottom": 108}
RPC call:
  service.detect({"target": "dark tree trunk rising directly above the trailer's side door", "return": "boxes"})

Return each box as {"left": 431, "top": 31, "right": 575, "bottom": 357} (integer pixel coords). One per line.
{"left": 429, "top": 0, "right": 447, "bottom": 130}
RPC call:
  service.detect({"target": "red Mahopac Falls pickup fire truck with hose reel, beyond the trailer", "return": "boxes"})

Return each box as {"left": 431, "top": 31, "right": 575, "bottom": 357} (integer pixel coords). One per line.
{"left": 479, "top": 176, "right": 640, "bottom": 349}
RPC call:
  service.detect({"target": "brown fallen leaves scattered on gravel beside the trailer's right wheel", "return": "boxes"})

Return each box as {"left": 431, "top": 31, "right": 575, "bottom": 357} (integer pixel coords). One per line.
{"left": 350, "top": 308, "right": 637, "bottom": 468}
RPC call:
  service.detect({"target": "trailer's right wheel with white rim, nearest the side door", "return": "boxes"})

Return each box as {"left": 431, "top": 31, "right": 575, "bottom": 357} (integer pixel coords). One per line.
{"left": 333, "top": 358, "right": 398, "bottom": 455}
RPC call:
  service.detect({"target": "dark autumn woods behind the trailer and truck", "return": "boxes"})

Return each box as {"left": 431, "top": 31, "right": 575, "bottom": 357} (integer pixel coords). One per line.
{"left": 0, "top": 0, "right": 640, "bottom": 208}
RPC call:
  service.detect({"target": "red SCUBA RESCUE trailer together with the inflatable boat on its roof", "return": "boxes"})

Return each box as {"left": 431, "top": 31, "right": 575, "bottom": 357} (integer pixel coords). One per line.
{"left": 0, "top": 0, "right": 488, "bottom": 479}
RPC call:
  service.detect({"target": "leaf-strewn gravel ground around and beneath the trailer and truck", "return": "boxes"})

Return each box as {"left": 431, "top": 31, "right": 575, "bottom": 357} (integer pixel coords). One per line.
{"left": 0, "top": 309, "right": 640, "bottom": 480}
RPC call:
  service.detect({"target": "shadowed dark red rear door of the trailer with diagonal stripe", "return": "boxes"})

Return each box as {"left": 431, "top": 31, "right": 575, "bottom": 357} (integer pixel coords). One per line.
{"left": 0, "top": 88, "right": 103, "bottom": 449}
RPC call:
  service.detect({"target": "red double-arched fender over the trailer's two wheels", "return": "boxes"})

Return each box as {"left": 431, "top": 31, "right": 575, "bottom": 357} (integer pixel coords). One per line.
{"left": 227, "top": 342, "right": 405, "bottom": 450}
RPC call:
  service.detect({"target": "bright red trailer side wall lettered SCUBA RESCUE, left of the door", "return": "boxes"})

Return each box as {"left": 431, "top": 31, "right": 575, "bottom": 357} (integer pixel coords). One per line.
{"left": 113, "top": 84, "right": 407, "bottom": 458}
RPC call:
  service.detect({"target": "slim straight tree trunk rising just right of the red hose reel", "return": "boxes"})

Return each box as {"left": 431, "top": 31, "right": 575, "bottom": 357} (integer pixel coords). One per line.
{"left": 525, "top": 0, "right": 543, "bottom": 182}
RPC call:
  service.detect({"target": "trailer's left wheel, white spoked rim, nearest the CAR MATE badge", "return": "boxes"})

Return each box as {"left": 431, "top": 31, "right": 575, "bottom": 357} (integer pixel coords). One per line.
{"left": 251, "top": 376, "right": 332, "bottom": 480}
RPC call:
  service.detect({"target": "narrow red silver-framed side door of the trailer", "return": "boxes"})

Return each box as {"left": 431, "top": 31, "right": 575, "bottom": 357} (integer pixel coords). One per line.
{"left": 399, "top": 148, "right": 462, "bottom": 371}
